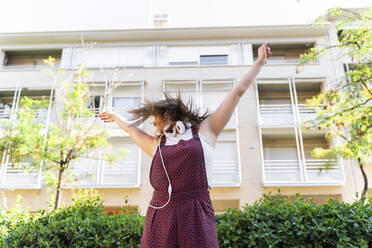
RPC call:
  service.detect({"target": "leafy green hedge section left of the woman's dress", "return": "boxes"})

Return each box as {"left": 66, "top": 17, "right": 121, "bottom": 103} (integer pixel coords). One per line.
{"left": 0, "top": 190, "right": 144, "bottom": 248}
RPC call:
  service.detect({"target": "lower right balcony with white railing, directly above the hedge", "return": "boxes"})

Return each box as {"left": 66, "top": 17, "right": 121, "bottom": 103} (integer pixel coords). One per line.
{"left": 262, "top": 131, "right": 344, "bottom": 186}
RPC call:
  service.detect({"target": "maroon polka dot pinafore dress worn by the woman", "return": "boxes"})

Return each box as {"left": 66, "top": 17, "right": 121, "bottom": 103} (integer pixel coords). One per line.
{"left": 140, "top": 127, "right": 219, "bottom": 248}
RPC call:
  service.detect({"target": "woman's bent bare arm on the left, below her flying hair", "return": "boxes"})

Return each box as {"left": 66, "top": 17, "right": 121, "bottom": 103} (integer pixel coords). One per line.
{"left": 98, "top": 111, "right": 158, "bottom": 157}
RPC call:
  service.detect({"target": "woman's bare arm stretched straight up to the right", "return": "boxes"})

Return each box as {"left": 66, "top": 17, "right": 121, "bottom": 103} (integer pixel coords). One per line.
{"left": 199, "top": 42, "right": 271, "bottom": 147}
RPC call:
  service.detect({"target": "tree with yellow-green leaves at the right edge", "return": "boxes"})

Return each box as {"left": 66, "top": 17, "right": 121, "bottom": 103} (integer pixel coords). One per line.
{"left": 297, "top": 7, "right": 372, "bottom": 200}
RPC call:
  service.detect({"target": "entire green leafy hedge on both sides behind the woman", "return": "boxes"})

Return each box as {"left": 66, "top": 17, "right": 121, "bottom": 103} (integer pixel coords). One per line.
{"left": 0, "top": 190, "right": 372, "bottom": 248}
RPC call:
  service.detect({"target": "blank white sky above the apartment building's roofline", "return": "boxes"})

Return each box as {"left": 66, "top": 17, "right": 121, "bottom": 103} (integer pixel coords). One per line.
{"left": 0, "top": 0, "right": 372, "bottom": 33}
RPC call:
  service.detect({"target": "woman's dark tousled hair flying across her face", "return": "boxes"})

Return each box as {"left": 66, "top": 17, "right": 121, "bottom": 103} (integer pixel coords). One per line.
{"left": 128, "top": 91, "right": 210, "bottom": 134}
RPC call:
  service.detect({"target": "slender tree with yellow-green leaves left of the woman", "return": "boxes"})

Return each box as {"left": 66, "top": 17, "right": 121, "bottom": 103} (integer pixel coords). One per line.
{"left": 0, "top": 54, "right": 127, "bottom": 209}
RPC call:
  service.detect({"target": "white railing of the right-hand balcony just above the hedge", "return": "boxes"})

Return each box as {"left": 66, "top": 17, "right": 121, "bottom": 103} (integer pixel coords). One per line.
{"left": 263, "top": 159, "right": 343, "bottom": 184}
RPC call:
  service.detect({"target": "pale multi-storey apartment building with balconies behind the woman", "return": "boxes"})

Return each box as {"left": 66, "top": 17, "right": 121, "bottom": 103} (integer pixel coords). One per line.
{"left": 0, "top": 22, "right": 372, "bottom": 214}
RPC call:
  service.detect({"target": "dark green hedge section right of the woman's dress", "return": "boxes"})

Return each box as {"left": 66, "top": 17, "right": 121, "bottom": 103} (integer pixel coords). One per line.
{"left": 216, "top": 192, "right": 372, "bottom": 248}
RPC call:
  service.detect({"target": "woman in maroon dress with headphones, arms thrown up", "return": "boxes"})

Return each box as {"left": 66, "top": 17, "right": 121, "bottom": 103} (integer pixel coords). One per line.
{"left": 98, "top": 42, "right": 271, "bottom": 248}
